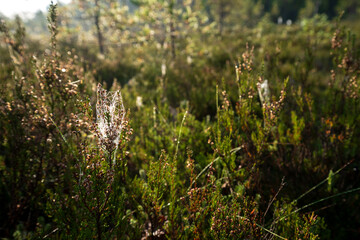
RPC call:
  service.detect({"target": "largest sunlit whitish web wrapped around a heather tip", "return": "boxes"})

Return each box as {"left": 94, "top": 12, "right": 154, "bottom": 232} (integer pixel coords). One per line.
{"left": 96, "top": 84, "right": 126, "bottom": 154}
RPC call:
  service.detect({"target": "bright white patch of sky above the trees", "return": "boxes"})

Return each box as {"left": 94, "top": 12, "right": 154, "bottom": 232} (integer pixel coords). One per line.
{"left": 0, "top": 0, "right": 71, "bottom": 17}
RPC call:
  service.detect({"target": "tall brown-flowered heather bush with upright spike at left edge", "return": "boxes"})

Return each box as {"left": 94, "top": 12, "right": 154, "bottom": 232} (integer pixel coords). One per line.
{"left": 1, "top": 2, "right": 91, "bottom": 237}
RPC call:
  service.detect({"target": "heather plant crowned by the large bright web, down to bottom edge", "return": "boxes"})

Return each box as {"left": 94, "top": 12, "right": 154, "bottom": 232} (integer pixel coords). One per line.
{"left": 47, "top": 80, "right": 132, "bottom": 239}
